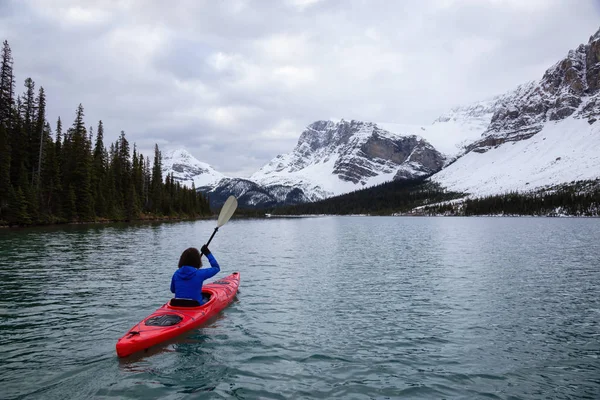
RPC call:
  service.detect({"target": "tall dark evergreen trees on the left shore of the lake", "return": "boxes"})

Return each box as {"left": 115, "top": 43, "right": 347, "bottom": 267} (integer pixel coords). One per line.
{"left": 0, "top": 41, "right": 210, "bottom": 225}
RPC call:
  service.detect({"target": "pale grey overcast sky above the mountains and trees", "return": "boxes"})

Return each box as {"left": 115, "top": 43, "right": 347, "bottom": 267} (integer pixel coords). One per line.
{"left": 0, "top": 0, "right": 600, "bottom": 176}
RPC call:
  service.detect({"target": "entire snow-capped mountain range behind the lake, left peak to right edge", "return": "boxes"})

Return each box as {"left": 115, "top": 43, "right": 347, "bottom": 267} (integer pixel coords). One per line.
{"left": 163, "top": 30, "right": 600, "bottom": 207}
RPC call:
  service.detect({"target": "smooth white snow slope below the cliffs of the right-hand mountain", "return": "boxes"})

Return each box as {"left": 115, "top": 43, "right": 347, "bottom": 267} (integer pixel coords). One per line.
{"left": 432, "top": 117, "right": 600, "bottom": 196}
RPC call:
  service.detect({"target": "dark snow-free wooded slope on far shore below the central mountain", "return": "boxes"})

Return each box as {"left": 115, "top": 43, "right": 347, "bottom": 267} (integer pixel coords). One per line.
{"left": 271, "top": 177, "right": 463, "bottom": 215}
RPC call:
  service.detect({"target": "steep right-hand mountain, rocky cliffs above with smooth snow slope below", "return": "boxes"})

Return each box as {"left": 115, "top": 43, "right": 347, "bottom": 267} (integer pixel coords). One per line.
{"left": 432, "top": 30, "right": 600, "bottom": 195}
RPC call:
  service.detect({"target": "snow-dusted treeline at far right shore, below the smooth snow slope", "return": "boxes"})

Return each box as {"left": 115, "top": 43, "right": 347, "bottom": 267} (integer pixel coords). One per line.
{"left": 424, "top": 179, "right": 600, "bottom": 217}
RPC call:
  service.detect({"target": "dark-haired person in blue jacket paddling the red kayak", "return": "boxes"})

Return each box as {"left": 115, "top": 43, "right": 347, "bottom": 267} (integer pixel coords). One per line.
{"left": 171, "top": 245, "right": 221, "bottom": 304}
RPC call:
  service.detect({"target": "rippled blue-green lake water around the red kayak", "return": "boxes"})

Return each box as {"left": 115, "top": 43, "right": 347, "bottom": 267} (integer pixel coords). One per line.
{"left": 0, "top": 217, "right": 600, "bottom": 399}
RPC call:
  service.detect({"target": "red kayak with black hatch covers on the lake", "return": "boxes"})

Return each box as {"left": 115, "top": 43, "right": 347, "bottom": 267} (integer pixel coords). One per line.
{"left": 117, "top": 272, "right": 240, "bottom": 357}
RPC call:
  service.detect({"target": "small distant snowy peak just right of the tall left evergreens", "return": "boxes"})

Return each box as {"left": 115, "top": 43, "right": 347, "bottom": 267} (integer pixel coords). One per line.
{"left": 162, "top": 149, "right": 226, "bottom": 188}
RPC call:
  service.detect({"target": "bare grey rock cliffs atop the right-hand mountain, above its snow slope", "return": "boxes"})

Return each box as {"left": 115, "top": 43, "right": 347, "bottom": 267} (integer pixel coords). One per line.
{"left": 467, "top": 26, "right": 600, "bottom": 152}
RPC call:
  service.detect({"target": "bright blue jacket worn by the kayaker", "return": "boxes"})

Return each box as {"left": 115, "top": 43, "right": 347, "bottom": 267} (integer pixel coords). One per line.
{"left": 171, "top": 254, "right": 221, "bottom": 304}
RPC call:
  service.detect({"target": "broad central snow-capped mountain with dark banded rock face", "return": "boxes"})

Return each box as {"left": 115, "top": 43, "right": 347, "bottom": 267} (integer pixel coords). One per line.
{"left": 250, "top": 120, "right": 444, "bottom": 200}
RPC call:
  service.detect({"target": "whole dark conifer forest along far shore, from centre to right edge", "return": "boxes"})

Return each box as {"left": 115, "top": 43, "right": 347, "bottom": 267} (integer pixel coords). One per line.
{"left": 268, "top": 177, "right": 600, "bottom": 216}
